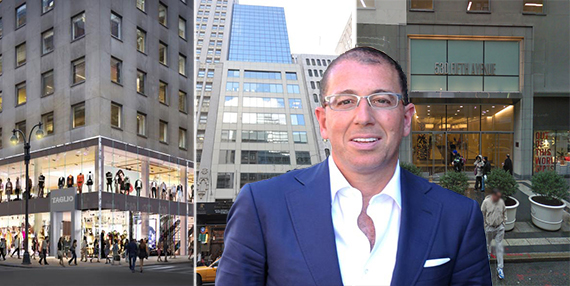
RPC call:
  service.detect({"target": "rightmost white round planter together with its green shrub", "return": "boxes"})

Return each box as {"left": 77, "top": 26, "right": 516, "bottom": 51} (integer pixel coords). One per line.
{"left": 528, "top": 171, "right": 568, "bottom": 231}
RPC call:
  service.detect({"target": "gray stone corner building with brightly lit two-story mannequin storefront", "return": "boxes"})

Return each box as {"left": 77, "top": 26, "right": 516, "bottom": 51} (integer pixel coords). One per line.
{"left": 0, "top": 0, "right": 194, "bottom": 256}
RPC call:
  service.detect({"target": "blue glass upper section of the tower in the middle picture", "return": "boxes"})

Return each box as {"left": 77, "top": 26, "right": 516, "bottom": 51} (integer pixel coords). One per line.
{"left": 228, "top": 4, "right": 291, "bottom": 63}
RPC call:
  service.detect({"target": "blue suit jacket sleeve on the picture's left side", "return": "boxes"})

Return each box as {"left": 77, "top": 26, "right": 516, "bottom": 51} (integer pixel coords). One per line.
{"left": 216, "top": 184, "right": 266, "bottom": 286}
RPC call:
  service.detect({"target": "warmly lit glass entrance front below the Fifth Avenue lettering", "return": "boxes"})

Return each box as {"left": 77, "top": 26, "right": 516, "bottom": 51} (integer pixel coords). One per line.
{"left": 412, "top": 104, "right": 514, "bottom": 177}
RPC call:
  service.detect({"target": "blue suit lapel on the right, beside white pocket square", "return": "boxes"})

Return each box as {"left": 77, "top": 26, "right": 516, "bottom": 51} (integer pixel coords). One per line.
{"left": 391, "top": 170, "right": 441, "bottom": 285}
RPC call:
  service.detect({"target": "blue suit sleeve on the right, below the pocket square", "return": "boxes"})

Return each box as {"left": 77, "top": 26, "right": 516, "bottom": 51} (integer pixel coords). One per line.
{"left": 450, "top": 201, "right": 492, "bottom": 285}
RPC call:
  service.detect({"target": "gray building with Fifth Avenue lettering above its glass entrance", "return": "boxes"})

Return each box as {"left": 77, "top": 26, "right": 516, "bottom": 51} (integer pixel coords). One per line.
{"left": 357, "top": 0, "right": 570, "bottom": 180}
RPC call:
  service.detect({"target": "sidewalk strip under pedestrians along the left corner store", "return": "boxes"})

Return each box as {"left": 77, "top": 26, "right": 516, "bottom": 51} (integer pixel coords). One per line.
{"left": 0, "top": 256, "right": 191, "bottom": 269}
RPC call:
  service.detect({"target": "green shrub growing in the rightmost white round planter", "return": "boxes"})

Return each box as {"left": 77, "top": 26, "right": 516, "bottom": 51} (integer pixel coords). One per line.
{"left": 531, "top": 171, "right": 568, "bottom": 206}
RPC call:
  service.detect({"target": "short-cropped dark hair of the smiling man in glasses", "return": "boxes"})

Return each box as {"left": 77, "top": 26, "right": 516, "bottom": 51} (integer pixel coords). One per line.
{"left": 321, "top": 47, "right": 408, "bottom": 104}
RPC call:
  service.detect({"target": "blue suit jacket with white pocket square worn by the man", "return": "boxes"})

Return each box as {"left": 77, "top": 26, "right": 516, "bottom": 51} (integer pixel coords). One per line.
{"left": 216, "top": 161, "right": 491, "bottom": 286}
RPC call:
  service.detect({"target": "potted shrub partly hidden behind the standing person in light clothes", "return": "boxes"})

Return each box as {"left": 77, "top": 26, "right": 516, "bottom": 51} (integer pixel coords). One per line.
{"left": 485, "top": 168, "right": 519, "bottom": 231}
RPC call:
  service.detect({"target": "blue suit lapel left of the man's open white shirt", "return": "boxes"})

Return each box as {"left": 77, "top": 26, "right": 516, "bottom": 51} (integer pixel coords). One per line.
{"left": 286, "top": 160, "right": 342, "bottom": 285}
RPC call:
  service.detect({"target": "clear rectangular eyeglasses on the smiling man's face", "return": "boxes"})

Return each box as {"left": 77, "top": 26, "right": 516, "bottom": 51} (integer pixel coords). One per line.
{"left": 325, "top": 92, "right": 402, "bottom": 111}
